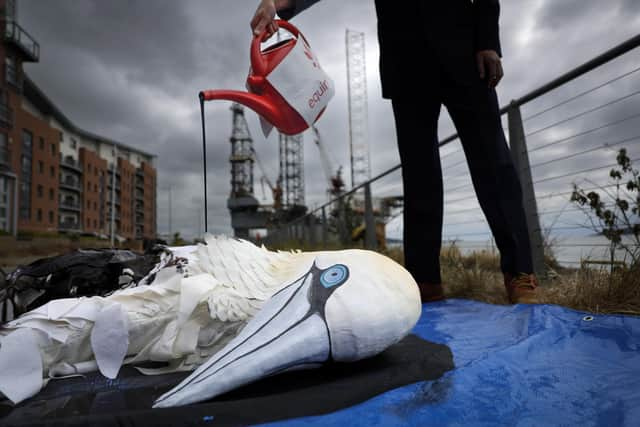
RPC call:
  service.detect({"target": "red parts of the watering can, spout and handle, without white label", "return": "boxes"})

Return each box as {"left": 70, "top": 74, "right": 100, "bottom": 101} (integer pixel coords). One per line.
{"left": 199, "top": 20, "right": 330, "bottom": 135}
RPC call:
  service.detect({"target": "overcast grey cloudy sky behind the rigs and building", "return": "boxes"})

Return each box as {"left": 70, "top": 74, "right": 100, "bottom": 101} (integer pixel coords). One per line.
{"left": 18, "top": 0, "right": 640, "bottom": 247}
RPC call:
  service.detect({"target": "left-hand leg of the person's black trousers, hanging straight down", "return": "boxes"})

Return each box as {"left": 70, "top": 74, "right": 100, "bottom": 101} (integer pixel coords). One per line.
{"left": 392, "top": 97, "right": 443, "bottom": 284}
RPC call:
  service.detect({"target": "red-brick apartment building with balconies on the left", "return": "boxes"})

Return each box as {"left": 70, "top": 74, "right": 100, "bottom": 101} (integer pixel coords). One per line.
{"left": 0, "top": 0, "right": 156, "bottom": 239}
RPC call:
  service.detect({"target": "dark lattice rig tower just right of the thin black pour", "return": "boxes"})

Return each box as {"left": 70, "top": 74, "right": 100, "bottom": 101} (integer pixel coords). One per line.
{"left": 227, "top": 103, "right": 268, "bottom": 239}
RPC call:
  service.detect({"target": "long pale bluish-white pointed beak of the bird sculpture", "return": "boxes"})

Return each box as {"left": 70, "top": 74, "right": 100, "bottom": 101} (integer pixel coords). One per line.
{"left": 153, "top": 266, "right": 331, "bottom": 408}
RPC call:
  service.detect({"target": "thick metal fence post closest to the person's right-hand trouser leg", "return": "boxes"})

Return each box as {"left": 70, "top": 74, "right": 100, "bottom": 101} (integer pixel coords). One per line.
{"left": 507, "top": 101, "right": 546, "bottom": 276}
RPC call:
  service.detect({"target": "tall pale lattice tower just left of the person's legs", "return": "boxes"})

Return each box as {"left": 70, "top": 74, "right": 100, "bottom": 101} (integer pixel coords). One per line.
{"left": 345, "top": 30, "right": 371, "bottom": 187}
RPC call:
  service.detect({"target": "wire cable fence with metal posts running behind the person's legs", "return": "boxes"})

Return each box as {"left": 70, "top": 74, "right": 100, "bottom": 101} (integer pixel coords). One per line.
{"left": 270, "top": 35, "right": 640, "bottom": 272}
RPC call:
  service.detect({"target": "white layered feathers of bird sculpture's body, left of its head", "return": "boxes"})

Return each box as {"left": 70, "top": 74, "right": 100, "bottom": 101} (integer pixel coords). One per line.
{"left": 0, "top": 236, "right": 308, "bottom": 401}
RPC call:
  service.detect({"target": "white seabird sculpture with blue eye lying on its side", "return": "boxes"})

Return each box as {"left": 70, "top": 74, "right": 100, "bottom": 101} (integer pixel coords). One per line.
{"left": 0, "top": 236, "right": 421, "bottom": 407}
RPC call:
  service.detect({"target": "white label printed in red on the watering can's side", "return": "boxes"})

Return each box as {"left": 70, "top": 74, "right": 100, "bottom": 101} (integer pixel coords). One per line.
{"left": 262, "top": 37, "right": 335, "bottom": 134}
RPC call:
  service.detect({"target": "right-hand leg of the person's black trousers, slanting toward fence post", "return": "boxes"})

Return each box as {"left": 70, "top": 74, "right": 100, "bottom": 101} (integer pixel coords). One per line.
{"left": 444, "top": 83, "right": 533, "bottom": 274}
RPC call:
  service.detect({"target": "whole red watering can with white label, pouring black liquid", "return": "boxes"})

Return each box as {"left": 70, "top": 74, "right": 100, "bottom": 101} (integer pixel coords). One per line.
{"left": 199, "top": 20, "right": 334, "bottom": 135}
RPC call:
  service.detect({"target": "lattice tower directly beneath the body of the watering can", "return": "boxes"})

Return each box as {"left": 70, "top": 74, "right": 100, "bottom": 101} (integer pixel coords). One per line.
{"left": 278, "top": 134, "right": 306, "bottom": 218}
